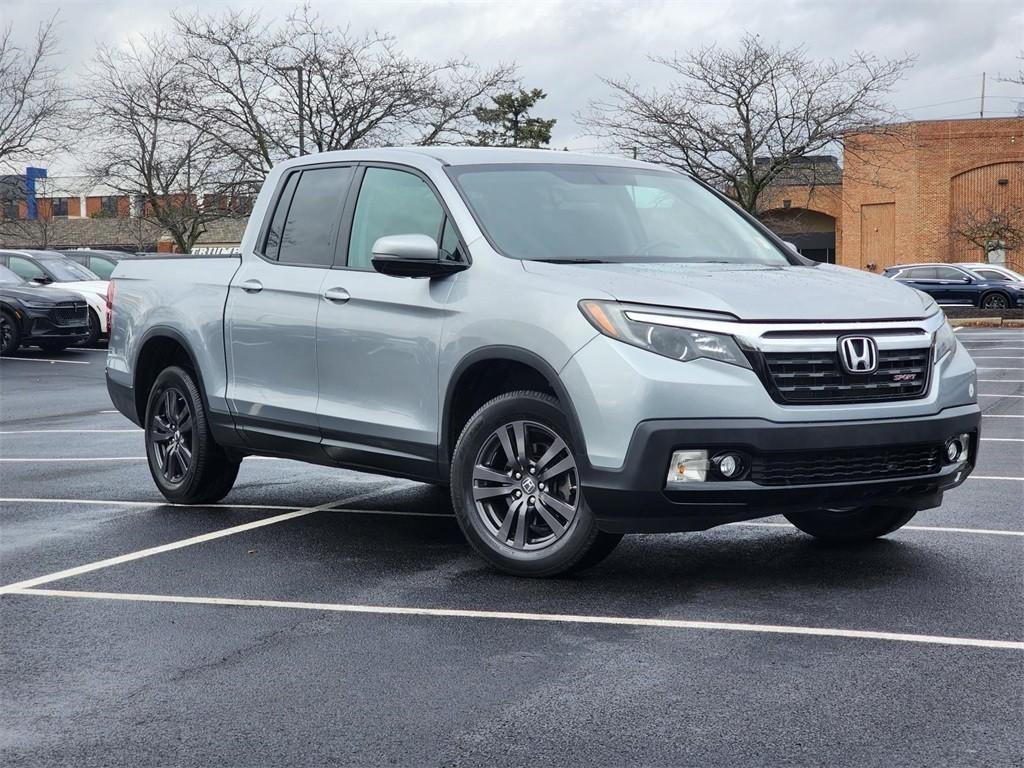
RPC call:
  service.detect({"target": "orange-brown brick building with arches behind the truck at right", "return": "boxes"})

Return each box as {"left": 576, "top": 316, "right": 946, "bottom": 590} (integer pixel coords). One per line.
{"left": 764, "top": 118, "right": 1024, "bottom": 271}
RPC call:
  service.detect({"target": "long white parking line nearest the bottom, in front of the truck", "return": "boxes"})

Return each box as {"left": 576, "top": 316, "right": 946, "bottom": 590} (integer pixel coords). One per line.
{"left": 8, "top": 588, "right": 1024, "bottom": 650}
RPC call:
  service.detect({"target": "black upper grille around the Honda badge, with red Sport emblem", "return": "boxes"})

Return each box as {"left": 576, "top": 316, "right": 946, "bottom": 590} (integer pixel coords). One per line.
{"left": 763, "top": 347, "right": 932, "bottom": 404}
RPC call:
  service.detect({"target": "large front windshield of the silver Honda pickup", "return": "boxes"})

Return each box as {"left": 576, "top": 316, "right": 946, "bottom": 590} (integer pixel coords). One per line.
{"left": 446, "top": 164, "right": 794, "bottom": 266}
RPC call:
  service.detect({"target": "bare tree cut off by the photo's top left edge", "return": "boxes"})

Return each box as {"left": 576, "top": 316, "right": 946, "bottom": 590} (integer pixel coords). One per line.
{"left": 0, "top": 16, "right": 71, "bottom": 165}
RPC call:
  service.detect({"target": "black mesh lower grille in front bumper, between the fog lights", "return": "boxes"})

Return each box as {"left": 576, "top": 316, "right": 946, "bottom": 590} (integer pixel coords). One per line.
{"left": 751, "top": 445, "right": 943, "bottom": 485}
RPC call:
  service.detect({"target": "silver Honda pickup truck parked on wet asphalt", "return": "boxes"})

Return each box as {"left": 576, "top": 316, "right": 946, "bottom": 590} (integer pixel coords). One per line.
{"left": 106, "top": 147, "right": 980, "bottom": 575}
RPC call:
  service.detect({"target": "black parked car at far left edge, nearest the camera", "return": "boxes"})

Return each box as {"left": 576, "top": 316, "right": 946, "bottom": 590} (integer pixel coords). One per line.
{"left": 0, "top": 266, "right": 89, "bottom": 355}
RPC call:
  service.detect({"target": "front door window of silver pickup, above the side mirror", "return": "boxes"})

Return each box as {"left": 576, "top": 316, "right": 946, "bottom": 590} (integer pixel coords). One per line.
{"left": 348, "top": 168, "right": 444, "bottom": 269}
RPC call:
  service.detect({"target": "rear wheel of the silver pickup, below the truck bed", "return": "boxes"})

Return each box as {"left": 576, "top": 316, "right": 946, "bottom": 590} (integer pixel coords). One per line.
{"left": 145, "top": 366, "right": 240, "bottom": 505}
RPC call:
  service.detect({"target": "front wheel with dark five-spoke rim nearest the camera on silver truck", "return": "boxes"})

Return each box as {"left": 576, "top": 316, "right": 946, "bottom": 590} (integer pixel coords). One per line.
{"left": 452, "top": 391, "right": 622, "bottom": 578}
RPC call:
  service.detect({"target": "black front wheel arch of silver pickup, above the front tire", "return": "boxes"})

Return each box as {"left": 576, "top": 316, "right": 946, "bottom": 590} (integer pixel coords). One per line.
{"left": 437, "top": 346, "right": 589, "bottom": 478}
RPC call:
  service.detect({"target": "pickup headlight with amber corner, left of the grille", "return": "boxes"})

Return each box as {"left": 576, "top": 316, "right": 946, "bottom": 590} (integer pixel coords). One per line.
{"left": 580, "top": 299, "right": 751, "bottom": 368}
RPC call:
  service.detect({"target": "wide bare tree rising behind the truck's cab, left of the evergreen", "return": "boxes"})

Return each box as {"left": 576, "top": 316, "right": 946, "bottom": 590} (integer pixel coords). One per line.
{"left": 174, "top": 7, "right": 515, "bottom": 180}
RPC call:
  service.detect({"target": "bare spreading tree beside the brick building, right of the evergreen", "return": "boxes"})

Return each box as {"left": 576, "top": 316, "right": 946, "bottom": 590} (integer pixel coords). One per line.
{"left": 580, "top": 36, "right": 912, "bottom": 214}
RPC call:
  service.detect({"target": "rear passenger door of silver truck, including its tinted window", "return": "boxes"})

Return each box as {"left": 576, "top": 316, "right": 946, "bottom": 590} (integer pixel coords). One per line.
{"left": 224, "top": 165, "right": 354, "bottom": 457}
